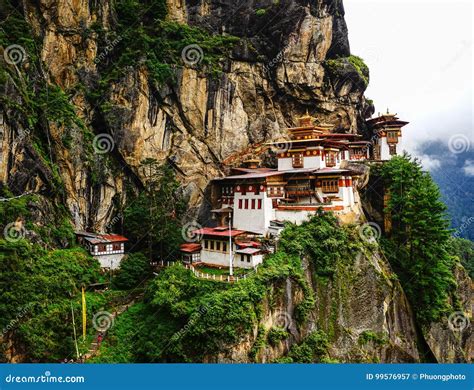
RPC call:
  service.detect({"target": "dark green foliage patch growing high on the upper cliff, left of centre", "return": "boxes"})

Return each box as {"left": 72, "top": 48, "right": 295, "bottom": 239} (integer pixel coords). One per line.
{"left": 92, "top": 0, "right": 238, "bottom": 89}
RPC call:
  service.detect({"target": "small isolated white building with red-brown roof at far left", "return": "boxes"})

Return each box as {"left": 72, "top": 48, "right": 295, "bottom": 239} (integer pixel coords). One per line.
{"left": 76, "top": 232, "right": 128, "bottom": 270}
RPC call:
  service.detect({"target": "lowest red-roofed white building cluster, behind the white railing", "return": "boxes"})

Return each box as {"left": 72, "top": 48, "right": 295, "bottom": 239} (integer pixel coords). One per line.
{"left": 181, "top": 226, "right": 263, "bottom": 268}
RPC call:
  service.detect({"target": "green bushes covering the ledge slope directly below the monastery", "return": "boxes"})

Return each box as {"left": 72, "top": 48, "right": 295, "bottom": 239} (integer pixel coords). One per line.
{"left": 89, "top": 213, "right": 380, "bottom": 362}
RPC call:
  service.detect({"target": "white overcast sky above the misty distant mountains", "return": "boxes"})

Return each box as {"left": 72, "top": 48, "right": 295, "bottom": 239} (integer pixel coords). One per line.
{"left": 344, "top": 0, "right": 474, "bottom": 168}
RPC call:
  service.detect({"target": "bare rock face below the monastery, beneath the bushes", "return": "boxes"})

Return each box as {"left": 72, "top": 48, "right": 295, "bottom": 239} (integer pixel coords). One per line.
{"left": 217, "top": 251, "right": 421, "bottom": 363}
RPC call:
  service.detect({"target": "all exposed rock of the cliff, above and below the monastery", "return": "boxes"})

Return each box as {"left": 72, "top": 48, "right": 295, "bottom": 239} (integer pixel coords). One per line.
{"left": 0, "top": 0, "right": 473, "bottom": 362}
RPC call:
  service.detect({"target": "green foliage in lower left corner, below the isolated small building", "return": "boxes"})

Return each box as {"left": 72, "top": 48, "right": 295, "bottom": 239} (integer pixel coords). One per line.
{"left": 0, "top": 240, "right": 99, "bottom": 361}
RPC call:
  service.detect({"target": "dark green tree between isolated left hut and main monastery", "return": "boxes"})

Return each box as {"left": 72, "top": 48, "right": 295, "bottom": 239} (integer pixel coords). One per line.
{"left": 124, "top": 159, "right": 186, "bottom": 259}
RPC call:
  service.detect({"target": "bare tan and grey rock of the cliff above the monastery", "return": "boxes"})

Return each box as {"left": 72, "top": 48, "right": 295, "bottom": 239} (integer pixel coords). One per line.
{"left": 1, "top": 0, "right": 370, "bottom": 230}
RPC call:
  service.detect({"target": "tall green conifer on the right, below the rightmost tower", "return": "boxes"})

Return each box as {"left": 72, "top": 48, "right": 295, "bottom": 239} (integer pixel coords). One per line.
{"left": 375, "top": 155, "right": 456, "bottom": 324}
